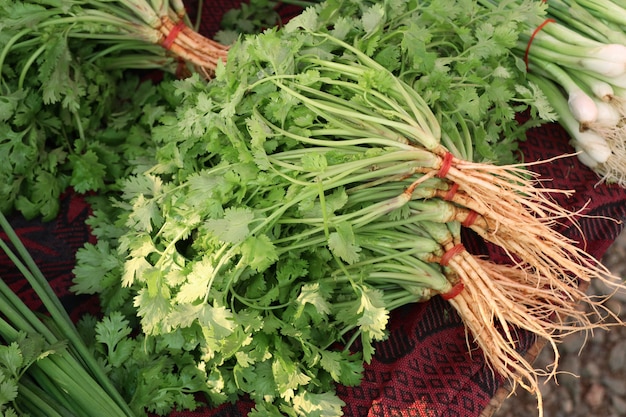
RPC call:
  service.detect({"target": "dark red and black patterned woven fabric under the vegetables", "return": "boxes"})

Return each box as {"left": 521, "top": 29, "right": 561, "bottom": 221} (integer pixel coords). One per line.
{"left": 0, "top": 0, "right": 626, "bottom": 417}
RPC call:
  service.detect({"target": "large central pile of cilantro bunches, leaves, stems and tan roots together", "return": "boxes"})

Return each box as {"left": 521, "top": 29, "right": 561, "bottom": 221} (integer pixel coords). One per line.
{"left": 5, "top": 0, "right": 619, "bottom": 417}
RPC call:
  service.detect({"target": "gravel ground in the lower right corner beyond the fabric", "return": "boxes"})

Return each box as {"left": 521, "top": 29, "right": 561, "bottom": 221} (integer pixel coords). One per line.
{"left": 493, "top": 230, "right": 626, "bottom": 417}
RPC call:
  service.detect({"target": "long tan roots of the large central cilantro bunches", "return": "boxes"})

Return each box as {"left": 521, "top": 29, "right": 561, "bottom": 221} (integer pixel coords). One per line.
{"left": 416, "top": 150, "right": 623, "bottom": 415}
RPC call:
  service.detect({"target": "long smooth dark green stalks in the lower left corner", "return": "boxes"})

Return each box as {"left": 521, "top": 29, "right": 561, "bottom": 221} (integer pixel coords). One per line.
{"left": 0, "top": 213, "right": 134, "bottom": 417}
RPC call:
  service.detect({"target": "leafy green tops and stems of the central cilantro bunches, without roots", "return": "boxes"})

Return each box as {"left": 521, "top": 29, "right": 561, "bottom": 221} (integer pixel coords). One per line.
{"left": 69, "top": 2, "right": 552, "bottom": 416}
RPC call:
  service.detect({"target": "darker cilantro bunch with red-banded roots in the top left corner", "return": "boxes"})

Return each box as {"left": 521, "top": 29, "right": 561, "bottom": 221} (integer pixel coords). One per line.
{"left": 0, "top": 0, "right": 227, "bottom": 220}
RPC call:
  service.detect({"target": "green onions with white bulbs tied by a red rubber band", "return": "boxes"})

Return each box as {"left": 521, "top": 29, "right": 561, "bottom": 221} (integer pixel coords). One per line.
{"left": 481, "top": 0, "right": 626, "bottom": 186}
